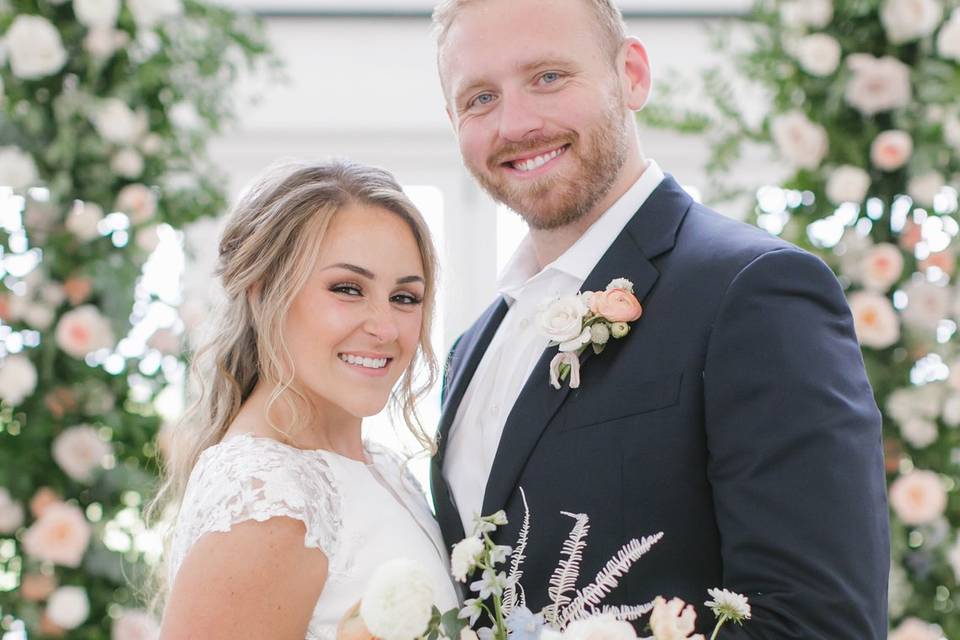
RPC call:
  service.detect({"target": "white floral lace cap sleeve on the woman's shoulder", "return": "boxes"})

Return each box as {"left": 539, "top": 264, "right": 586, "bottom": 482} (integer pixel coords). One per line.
{"left": 169, "top": 434, "right": 342, "bottom": 584}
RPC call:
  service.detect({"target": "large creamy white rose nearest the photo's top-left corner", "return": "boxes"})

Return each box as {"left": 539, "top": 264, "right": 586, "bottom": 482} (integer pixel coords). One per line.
{"left": 4, "top": 15, "right": 67, "bottom": 80}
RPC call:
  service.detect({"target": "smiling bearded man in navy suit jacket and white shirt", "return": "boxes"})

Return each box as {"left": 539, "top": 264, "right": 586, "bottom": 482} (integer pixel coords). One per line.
{"left": 432, "top": 0, "right": 889, "bottom": 640}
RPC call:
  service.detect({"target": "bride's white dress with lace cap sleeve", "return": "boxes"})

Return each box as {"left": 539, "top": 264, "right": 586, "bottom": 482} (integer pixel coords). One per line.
{"left": 169, "top": 434, "right": 457, "bottom": 640}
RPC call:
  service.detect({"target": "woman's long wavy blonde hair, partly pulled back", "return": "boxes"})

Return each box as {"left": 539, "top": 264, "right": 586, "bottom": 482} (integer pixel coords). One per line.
{"left": 150, "top": 161, "right": 438, "bottom": 568}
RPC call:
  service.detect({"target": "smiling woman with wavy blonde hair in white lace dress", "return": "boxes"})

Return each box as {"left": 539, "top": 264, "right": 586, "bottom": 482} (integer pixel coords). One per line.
{"left": 161, "top": 162, "right": 457, "bottom": 640}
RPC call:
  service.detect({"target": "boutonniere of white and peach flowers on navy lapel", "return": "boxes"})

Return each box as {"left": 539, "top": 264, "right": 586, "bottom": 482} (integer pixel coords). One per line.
{"left": 538, "top": 278, "right": 643, "bottom": 389}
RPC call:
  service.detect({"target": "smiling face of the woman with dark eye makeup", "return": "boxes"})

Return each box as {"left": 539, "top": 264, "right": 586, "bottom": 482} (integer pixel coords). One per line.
{"left": 284, "top": 205, "right": 425, "bottom": 417}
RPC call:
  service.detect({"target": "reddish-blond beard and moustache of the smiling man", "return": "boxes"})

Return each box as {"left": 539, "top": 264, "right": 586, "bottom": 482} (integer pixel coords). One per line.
{"left": 467, "top": 100, "right": 629, "bottom": 229}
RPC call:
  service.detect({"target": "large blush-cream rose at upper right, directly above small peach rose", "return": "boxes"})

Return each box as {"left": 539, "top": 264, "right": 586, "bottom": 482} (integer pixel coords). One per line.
{"left": 846, "top": 53, "right": 913, "bottom": 116}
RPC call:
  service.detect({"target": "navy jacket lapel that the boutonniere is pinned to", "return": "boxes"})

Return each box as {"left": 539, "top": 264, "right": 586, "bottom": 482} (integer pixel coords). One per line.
{"left": 482, "top": 177, "right": 693, "bottom": 515}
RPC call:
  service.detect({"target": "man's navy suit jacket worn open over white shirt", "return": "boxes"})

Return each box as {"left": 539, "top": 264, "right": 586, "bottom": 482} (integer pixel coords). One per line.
{"left": 431, "top": 177, "right": 889, "bottom": 640}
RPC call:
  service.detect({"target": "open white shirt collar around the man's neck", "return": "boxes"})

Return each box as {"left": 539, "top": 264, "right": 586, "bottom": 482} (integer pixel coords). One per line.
{"left": 498, "top": 160, "right": 664, "bottom": 303}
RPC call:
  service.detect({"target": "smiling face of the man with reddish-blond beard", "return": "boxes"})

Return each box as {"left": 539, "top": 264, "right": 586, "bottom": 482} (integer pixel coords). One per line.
{"left": 440, "top": 0, "right": 631, "bottom": 229}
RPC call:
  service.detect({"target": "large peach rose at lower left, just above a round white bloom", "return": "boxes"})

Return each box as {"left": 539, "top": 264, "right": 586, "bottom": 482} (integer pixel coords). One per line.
{"left": 23, "top": 503, "right": 91, "bottom": 569}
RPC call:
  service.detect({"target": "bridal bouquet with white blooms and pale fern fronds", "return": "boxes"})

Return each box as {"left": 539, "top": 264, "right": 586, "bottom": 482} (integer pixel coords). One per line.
{"left": 337, "top": 491, "right": 750, "bottom": 640}
